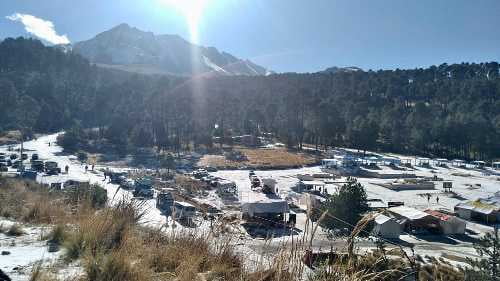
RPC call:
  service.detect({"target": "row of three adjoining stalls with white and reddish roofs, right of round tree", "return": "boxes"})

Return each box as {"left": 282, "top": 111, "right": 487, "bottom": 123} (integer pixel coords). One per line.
{"left": 373, "top": 206, "right": 466, "bottom": 238}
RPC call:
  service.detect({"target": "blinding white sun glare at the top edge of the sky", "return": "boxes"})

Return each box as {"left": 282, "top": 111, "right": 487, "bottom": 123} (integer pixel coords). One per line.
{"left": 160, "top": 0, "right": 209, "bottom": 43}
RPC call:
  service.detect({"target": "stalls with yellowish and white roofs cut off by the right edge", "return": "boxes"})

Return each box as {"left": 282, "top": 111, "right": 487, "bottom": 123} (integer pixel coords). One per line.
{"left": 455, "top": 191, "right": 500, "bottom": 224}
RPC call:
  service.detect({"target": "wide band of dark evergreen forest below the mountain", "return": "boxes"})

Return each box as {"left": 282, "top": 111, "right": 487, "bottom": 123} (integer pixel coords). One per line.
{"left": 0, "top": 38, "right": 500, "bottom": 160}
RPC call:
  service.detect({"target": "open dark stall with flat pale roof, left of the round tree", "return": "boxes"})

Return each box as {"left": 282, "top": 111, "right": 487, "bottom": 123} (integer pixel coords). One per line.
{"left": 241, "top": 199, "right": 290, "bottom": 221}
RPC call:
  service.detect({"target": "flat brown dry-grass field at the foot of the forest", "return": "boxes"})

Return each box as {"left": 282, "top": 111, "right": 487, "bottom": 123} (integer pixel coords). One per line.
{"left": 198, "top": 148, "right": 318, "bottom": 169}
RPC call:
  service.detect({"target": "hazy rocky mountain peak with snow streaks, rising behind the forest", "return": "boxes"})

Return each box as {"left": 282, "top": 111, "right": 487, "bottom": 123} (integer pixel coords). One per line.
{"left": 73, "top": 23, "right": 269, "bottom": 75}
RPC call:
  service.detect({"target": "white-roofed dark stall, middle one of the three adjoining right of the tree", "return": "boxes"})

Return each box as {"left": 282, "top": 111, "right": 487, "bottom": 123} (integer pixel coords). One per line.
{"left": 388, "top": 206, "right": 439, "bottom": 234}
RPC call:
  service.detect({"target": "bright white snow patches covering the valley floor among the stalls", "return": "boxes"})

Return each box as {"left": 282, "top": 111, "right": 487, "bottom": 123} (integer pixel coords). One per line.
{"left": 0, "top": 134, "right": 500, "bottom": 272}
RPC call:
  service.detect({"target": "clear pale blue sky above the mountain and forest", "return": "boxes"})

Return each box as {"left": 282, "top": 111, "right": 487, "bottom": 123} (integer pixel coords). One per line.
{"left": 0, "top": 0, "right": 500, "bottom": 72}
